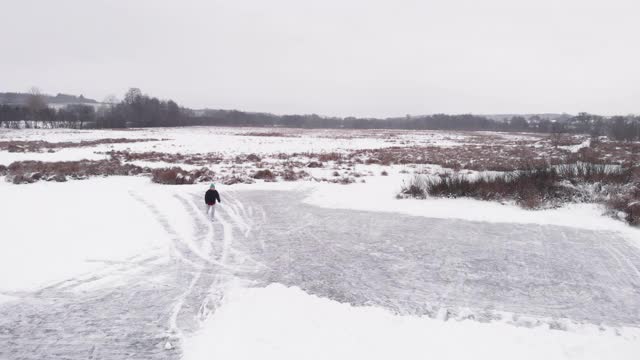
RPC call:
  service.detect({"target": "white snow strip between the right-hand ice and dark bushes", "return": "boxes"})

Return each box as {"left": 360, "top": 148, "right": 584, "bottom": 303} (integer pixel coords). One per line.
{"left": 304, "top": 173, "right": 640, "bottom": 247}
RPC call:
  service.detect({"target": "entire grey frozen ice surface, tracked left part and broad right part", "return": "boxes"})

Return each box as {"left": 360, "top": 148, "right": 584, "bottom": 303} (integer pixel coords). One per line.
{"left": 0, "top": 190, "right": 640, "bottom": 360}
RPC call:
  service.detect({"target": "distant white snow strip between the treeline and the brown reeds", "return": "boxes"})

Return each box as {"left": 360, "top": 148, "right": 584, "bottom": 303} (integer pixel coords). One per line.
{"left": 0, "top": 127, "right": 552, "bottom": 165}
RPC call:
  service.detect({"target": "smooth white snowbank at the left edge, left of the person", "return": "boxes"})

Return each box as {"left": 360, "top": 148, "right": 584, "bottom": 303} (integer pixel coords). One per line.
{"left": 0, "top": 177, "right": 168, "bottom": 291}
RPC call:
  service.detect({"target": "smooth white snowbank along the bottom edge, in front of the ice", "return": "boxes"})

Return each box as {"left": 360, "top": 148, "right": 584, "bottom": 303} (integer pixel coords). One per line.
{"left": 184, "top": 284, "right": 640, "bottom": 360}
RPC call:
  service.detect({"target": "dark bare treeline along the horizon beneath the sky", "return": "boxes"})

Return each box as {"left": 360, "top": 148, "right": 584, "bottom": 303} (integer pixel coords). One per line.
{"left": 0, "top": 88, "right": 640, "bottom": 140}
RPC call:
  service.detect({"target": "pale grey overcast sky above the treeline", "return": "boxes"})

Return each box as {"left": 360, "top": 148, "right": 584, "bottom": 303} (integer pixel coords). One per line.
{"left": 0, "top": 0, "right": 640, "bottom": 117}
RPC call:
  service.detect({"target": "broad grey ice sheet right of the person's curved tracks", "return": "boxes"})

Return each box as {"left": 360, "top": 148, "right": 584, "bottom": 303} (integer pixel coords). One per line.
{"left": 238, "top": 192, "right": 640, "bottom": 326}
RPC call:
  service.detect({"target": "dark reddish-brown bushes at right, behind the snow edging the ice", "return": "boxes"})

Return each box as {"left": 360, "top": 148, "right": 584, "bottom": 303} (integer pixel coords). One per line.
{"left": 400, "top": 163, "right": 640, "bottom": 225}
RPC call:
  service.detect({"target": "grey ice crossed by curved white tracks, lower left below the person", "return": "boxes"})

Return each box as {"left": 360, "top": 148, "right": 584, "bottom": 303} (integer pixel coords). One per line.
{"left": 0, "top": 193, "right": 260, "bottom": 360}
